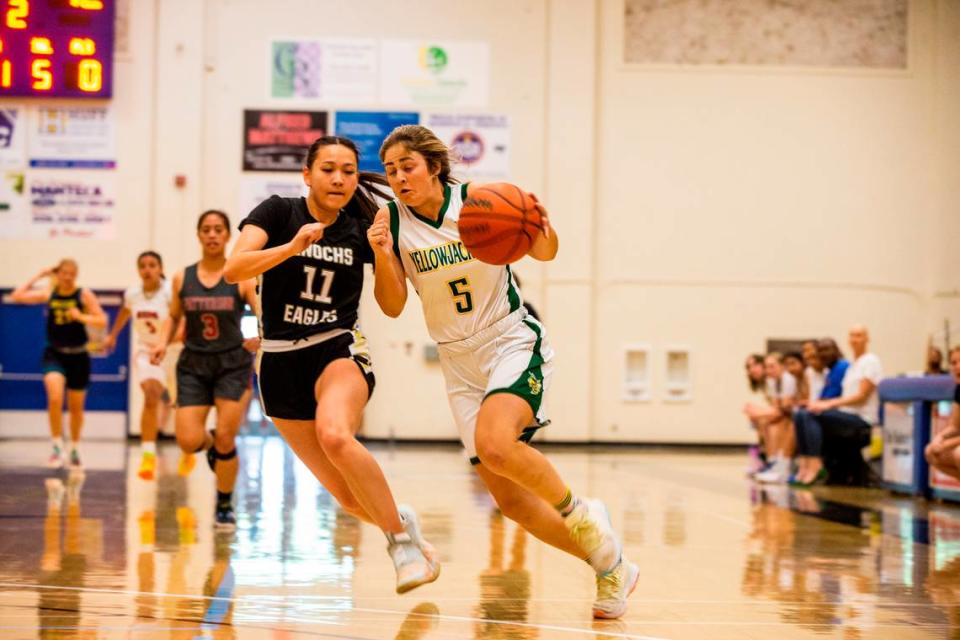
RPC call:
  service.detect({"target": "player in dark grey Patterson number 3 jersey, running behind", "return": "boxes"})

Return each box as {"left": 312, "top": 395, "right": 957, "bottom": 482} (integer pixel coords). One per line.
{"left": 151, "top": 210, "right": 259, "bottom": 529}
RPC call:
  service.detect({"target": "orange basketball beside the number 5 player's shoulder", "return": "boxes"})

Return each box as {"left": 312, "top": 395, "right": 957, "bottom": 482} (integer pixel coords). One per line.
{"left": 457, "top": 182, "right": 543, "bottom": 264}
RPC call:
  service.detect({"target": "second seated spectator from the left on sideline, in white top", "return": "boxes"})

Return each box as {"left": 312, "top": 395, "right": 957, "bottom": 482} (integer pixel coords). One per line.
{"left": 744, "top": 352, "right": 797, "bottom": 483}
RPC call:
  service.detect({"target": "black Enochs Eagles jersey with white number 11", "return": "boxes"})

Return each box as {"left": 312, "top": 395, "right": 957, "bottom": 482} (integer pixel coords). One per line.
{"left": 240, "top": 196, "right": 373, "bottom": 341}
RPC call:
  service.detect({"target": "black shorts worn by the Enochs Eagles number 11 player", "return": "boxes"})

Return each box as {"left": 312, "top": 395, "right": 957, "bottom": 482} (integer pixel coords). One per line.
{"left": 257, "top": 331, "right": 376, "bottom": 420}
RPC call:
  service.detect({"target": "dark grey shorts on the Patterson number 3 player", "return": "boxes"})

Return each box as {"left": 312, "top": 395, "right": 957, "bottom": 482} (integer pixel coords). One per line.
{"left": 177, "top": 347, "right": 253, "bottom": 407}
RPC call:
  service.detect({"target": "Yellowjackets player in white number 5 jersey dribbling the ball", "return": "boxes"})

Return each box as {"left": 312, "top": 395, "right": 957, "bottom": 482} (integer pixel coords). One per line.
{"left": 368, "top": 125, "right": 639, "bottom": 618}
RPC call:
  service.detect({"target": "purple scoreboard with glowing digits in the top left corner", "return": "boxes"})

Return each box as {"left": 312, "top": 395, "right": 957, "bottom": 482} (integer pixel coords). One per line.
{"left": 0, "top": 0, "right": 116, "bottom": 98}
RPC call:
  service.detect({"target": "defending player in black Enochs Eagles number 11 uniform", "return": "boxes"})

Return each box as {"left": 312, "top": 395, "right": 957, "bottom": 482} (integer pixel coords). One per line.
{"left": 224, "top": 136, "right": 440, "bottom": 593}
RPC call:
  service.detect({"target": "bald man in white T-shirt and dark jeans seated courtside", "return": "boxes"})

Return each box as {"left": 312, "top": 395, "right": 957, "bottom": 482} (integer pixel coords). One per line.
{"left": 795, "top": 325, "right": 883, "bottom": 486}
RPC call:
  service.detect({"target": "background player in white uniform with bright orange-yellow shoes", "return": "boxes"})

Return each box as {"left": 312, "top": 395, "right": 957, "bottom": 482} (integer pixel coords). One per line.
{"left": 103, "top": 251, "right": 172, "bottom": 480}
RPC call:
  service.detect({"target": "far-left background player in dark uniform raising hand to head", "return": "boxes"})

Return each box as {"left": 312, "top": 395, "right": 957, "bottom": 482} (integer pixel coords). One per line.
{"left": 10, "top": 258, "right": 107, "bottom": 469}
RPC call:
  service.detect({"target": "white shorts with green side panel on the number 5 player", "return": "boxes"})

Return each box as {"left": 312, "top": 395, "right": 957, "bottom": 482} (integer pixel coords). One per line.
{"left": 438, "top": 308, "right": 553, "bottom": 464}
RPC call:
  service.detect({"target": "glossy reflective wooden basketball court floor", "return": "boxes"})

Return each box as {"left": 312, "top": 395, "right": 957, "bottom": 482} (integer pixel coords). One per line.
{"left": 0, "top": 442, "right": 960, "bottom": 640}
